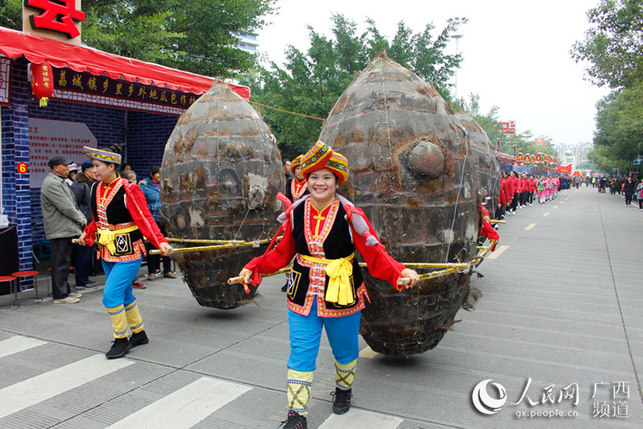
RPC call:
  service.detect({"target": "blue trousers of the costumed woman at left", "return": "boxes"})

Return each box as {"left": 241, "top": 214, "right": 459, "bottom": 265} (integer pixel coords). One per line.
{"left": 101, "top": 259, "right": 143, "bottom": 308}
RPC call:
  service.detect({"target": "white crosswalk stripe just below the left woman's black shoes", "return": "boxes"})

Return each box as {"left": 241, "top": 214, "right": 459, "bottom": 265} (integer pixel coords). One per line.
{"left": 0, "top": 354, "right": 134, "bottom": 418}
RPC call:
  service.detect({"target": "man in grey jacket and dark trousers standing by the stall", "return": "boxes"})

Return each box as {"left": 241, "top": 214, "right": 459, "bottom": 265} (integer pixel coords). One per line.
{"left": 40, "top": 155, "right": 87, "bottom": 304}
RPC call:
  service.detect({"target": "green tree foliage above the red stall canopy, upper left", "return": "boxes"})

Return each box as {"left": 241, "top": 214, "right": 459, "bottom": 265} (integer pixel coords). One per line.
{"left": 0, "top": 0, "right": 276, "bottom": 77}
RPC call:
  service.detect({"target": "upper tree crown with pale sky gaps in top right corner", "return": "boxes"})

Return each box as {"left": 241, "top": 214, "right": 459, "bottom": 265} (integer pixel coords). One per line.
{"left": 571, "top": 0, "right": 643, "bottom": 88}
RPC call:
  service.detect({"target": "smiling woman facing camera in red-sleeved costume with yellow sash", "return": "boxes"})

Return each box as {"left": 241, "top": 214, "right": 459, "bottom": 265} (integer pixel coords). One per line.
{"left": 239, "top": 141, "right": 419, "bottom": 428}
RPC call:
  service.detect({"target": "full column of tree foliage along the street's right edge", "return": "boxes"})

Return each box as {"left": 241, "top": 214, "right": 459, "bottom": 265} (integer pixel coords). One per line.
{"left": 572, "top": 0, "right": 643, "bottom": 173}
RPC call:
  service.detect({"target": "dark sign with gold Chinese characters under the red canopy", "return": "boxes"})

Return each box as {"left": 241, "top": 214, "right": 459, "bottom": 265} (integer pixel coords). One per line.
{"left": 50, "top": 68, "right": 199, "bottom": 116}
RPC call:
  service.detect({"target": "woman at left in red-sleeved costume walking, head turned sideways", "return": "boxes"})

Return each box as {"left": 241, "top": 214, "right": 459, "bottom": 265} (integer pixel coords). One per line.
{"left": 78, "top": 146, "right": 172, "bottom": 359}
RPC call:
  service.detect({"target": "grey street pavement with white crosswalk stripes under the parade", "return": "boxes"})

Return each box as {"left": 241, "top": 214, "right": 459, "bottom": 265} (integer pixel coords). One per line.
{"left": 0, "top": 187, "right": 643, "bottom": 429}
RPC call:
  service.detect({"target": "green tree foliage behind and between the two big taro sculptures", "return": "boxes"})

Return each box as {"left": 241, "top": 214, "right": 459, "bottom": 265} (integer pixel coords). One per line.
{"left": 242, "top": 14, "right": 461, "bottom": 158}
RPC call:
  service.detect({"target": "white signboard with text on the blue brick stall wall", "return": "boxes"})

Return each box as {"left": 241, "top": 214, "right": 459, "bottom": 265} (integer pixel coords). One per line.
{"left": 29, "top": 118, "right": 97, "bottom": 188}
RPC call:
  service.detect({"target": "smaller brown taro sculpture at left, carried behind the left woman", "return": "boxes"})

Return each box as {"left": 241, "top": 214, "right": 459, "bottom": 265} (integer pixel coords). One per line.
{"left": 161, "top": 83, "right": 283, "bottom": 308}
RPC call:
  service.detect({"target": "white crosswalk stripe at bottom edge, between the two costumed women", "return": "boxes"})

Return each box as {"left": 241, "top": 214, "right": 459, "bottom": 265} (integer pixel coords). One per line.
{"left": 110, "top": 377, "right": 251, "bottom": 429}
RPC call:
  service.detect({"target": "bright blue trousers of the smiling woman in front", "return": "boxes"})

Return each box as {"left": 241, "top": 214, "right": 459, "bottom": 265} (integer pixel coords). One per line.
{"left": 287, "top": 301, "right": 362, "bottom": 371}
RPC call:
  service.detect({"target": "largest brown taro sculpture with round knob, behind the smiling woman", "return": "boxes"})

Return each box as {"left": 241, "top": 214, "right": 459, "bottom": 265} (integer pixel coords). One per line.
{"left": 320, "top": 55, "right": 495, "bottom": 356}
